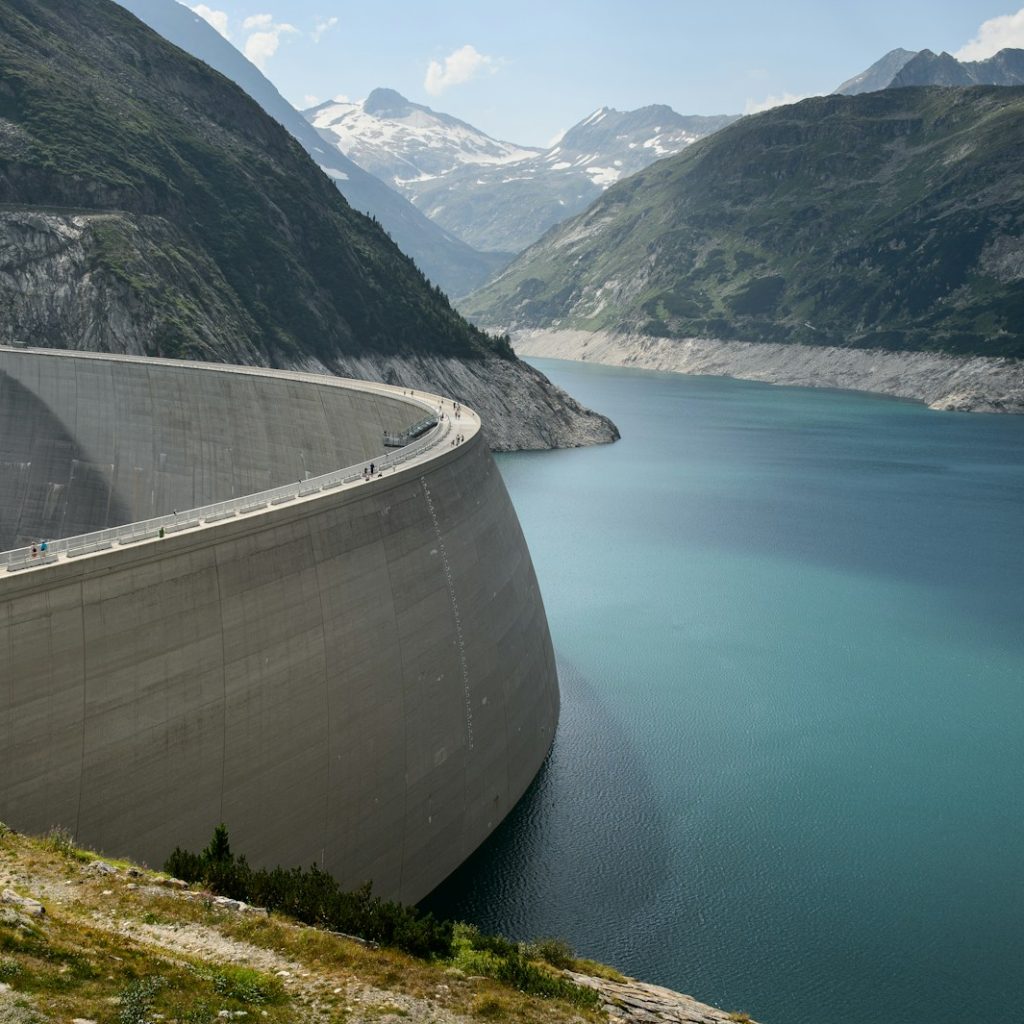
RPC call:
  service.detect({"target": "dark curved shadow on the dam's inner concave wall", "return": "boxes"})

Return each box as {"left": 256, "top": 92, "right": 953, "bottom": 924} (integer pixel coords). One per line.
{"left": 0, "top": 371, "right": 131, "bottom": 551}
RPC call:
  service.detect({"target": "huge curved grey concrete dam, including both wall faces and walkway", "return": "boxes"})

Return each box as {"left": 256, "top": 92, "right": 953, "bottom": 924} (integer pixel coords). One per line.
{"left": 0, "top": 348, "right": 559, "bottom": 901}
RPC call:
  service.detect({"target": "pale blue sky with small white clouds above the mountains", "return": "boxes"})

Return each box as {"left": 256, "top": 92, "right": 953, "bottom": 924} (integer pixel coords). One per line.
{"left": 186, "top": 0, "right": 1024, "bottom": 145}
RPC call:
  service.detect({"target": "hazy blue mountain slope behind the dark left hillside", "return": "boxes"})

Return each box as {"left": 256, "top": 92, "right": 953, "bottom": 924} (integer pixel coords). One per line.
{"left": 119, "top": 0, "right": 508, "bottom": 295}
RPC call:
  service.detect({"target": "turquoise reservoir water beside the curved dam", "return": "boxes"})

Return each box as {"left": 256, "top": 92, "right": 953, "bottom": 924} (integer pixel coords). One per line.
{"left": 421, "top": 360, "right": 1024, "bottom": 1024}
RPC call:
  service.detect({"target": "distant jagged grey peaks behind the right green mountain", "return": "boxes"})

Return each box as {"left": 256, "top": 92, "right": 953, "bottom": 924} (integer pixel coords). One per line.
{"left": 836, "top": 48, "right": 1024, "bottom": 96}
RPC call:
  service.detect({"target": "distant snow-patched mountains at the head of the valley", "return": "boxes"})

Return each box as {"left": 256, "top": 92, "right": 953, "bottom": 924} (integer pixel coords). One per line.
{"left": 306, "top": 89, "right": 735, "bottom": 253}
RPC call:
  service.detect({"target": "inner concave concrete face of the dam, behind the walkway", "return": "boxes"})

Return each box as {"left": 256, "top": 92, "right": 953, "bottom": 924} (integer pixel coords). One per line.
{"left": 0, "top": 349, "right": 424, "bottom": 551}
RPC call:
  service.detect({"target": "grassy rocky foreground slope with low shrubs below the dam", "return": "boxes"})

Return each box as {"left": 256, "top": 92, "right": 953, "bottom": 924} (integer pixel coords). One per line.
{"left": 0, "top": 823, "right": 750, "bottom": 1024}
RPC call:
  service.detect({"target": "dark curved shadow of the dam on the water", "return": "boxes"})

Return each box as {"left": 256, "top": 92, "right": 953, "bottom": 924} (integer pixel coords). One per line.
{"left": 421, "top": 660, "right": 669, "bottom": 969}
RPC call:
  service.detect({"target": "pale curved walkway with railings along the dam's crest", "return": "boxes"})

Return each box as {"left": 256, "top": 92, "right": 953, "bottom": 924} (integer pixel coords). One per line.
{"left": 0, "top": 348, "right": 468, "bottom": 572}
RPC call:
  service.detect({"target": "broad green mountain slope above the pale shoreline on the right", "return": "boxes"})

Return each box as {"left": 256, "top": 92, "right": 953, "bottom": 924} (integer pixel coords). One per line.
{"left": 463, "top": 87, "right": 1024, "bottom": 356}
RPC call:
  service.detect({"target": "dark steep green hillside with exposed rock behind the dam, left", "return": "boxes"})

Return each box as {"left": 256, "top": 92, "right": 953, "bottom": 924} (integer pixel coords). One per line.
{"left": 0, "top": 0, "right": 509, "bottom": 365}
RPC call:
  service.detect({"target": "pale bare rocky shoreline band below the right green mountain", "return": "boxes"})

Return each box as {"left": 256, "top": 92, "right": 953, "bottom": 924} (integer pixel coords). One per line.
{"left": 512, "top": 330, "right": 1024, "bottom": 413}
